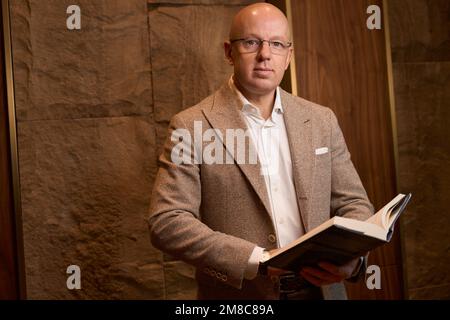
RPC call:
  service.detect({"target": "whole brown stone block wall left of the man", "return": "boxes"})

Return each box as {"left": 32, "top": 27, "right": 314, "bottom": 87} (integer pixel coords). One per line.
{"left": 10, "top": 0, "right": 252, "bottom": 299}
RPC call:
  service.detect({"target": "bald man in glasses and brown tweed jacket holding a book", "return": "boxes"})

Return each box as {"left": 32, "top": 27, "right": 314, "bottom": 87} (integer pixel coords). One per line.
{"left": 149, "top": 3, "right": 373, "bottom": 299}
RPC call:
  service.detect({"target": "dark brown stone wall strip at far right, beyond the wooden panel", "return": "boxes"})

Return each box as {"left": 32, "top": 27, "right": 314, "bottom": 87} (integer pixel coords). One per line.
{"left": 389, "top": 0, "right": 450, "bottom": 299}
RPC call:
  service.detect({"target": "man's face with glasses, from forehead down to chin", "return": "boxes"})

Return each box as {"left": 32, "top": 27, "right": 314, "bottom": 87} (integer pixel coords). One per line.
{"left": 225, "top": 14, "right": 292, "bottom": 95}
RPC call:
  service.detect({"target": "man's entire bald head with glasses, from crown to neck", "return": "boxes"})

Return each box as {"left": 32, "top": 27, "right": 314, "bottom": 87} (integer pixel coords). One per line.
{"left": 223, "top": 3, "right": 293, "bottom": 102}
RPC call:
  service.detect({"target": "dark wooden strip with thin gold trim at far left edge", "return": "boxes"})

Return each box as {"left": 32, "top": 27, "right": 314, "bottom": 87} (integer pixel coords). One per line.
{"left": 0, "top": 0, "right": 26, "bottom": 299}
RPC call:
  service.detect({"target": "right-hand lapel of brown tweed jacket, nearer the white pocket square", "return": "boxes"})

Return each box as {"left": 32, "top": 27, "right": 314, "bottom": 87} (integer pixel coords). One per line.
{"left": 280, "top": 90, "right": 314, "bottom": 232}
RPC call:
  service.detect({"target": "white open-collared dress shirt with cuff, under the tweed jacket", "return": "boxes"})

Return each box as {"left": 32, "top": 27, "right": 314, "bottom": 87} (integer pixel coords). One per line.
{"left": 229, "top": 77, "right": 304, "bottom": 279}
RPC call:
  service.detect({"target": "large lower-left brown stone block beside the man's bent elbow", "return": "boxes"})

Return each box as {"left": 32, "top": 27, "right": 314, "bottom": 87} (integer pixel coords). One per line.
{"left": 18, "top": 117, "right": 164, "bottom": 299}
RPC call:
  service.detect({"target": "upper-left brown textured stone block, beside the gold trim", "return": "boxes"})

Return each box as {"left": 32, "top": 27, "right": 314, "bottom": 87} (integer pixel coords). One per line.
{"left": 11, "top": 0, "right": 152, "bottom": 121}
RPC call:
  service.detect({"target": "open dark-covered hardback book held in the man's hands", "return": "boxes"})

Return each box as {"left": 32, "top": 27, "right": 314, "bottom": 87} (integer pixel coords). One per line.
{"left": 262, "top": 193, "right": 411, "bottom": 271}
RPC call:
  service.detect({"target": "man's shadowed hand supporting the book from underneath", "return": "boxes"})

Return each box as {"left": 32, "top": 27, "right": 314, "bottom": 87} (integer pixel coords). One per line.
{"left": 300, "top": 258, "right": 359, "bottom": 287}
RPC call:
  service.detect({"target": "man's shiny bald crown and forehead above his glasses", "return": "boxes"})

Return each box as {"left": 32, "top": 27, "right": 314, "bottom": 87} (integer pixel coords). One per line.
{"left": 230, "top": 2, "right": 290, "bottom": 40}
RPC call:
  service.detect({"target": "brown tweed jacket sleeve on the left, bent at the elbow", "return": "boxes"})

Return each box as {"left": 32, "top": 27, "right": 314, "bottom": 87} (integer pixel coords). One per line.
{"left": 148, "top": 116, "right": 255, "bottom": 288}
